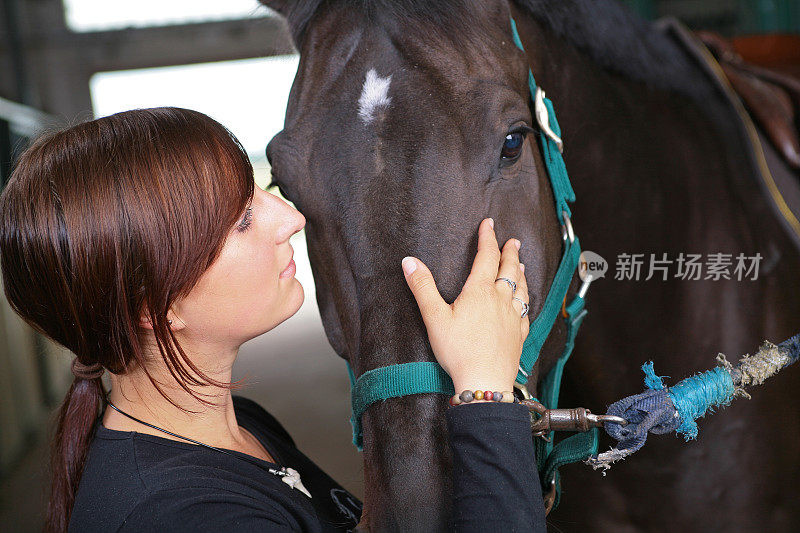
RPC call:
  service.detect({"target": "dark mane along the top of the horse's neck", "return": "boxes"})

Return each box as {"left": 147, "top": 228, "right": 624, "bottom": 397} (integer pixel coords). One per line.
{"left": 514, "top": 0, "right": 705, "bottom": 96}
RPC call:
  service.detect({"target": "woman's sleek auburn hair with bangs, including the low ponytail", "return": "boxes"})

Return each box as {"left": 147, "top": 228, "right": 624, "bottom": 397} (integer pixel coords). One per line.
{"left": 0, "top": 107, "right": 254, "bottom": 531}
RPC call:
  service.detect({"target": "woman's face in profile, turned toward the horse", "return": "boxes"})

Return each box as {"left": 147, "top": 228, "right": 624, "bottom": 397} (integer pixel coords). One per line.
{"left": 170, "top": 187, "right": 306, "bottom": 348}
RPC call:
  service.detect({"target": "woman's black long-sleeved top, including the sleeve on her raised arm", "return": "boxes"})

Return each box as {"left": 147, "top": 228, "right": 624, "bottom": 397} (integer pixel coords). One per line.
{"left": 69, "top": 396, "right": 545, "bottom": 532}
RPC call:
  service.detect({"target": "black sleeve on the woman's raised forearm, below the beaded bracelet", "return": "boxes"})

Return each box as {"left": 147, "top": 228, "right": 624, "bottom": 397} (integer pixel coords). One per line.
{"left": 446, "top": 402, "right": 546, "bottom": 533}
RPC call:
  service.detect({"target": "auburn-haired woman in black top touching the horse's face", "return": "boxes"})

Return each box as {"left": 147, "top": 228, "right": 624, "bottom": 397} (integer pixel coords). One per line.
{"left": 0, "top": 108, "right": 544, "bottom": 531}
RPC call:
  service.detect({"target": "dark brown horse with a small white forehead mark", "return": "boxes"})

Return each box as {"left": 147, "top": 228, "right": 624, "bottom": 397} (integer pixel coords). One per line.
{"left": 262, "top": 0, "right": 800, "bottom": 531}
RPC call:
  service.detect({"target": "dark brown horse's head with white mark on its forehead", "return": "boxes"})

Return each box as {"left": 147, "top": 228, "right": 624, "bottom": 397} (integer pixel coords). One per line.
{"left": 262, "top": 0, "right": 561, "bottom": 529}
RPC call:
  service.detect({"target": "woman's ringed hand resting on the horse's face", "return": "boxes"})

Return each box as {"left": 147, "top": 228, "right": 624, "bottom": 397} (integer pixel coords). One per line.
{"left": 403, "top": 219, "right": 530, "bottom": 400}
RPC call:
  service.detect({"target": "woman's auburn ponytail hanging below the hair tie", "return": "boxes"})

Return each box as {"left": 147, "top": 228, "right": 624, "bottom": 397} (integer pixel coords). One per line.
{"left": 45, "top": 372, "right": 105, "bottom": 533}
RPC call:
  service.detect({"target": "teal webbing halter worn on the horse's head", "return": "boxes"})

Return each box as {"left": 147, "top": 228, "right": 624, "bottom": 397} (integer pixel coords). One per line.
{"left": 347, "top": 18, "right": 597, "bottom": 504}
